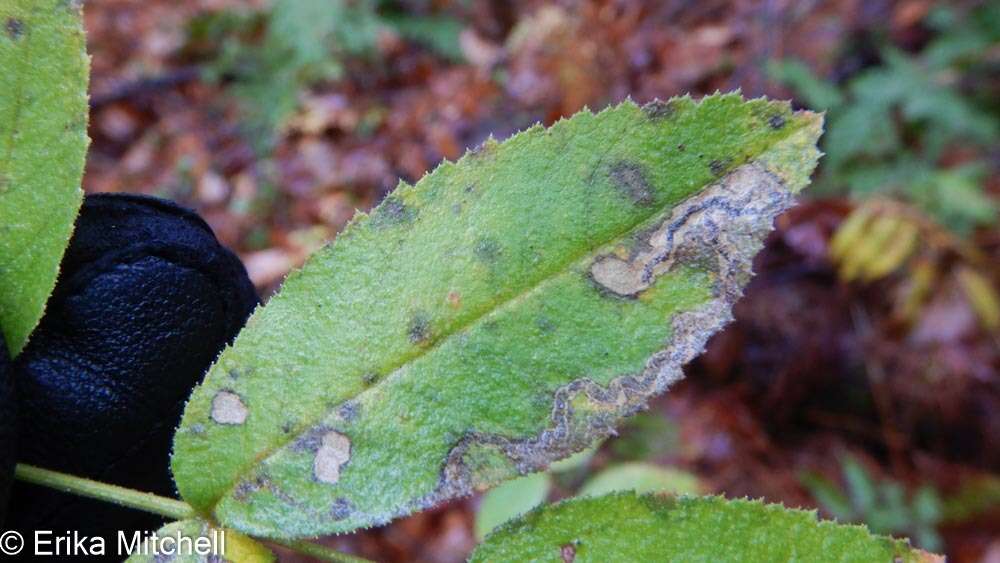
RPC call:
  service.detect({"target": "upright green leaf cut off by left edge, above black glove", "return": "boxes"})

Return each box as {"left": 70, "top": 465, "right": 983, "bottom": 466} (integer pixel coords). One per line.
{"left": 0, "top": 0, "right": 89, "bottom": 355}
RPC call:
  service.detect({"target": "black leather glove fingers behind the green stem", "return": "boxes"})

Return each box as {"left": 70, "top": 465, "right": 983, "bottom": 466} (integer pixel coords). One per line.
{"left": 6, "top": 195, "right": 258, "bottom": 559}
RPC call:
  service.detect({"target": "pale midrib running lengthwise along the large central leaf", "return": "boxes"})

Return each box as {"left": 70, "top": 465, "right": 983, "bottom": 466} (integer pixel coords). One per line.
{"left": 211, "top": 107, "right": 805, "bottom": 513}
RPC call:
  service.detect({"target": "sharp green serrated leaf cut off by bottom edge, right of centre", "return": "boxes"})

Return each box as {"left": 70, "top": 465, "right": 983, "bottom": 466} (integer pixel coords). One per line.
{"left": 471, "top": 493, "right": 933, "bottom": 563}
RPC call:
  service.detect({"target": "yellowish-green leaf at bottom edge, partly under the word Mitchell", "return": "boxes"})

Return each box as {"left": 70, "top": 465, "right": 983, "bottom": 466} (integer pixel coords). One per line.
{"left": 125, "top": 518, "right": 276, "bottom": 563}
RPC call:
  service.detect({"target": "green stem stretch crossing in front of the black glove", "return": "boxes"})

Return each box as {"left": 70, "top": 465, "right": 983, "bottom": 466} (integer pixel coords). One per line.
{"left": 14, "top": 463, "right": 196, "bottom": 520}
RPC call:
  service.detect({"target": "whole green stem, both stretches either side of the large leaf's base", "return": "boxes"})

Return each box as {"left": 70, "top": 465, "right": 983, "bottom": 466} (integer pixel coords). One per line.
{"left": 14, "top": 463, "right": 371, "bottom": 563}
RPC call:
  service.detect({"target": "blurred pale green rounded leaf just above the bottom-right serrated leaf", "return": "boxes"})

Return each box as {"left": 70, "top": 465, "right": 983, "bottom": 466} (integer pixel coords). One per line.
{"left": 580, "top": 463, "right": 701, "bottom": 497}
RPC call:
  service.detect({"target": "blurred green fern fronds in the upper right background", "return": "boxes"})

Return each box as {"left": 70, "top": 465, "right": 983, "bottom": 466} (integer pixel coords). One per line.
{"left": 767, "top": 2, "right": 1000, "bottom": 235}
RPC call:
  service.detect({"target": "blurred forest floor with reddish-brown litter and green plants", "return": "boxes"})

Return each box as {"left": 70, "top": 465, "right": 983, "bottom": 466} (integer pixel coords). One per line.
{"left": 84, "top": 0, "right": 1000, "bottom": 562}
